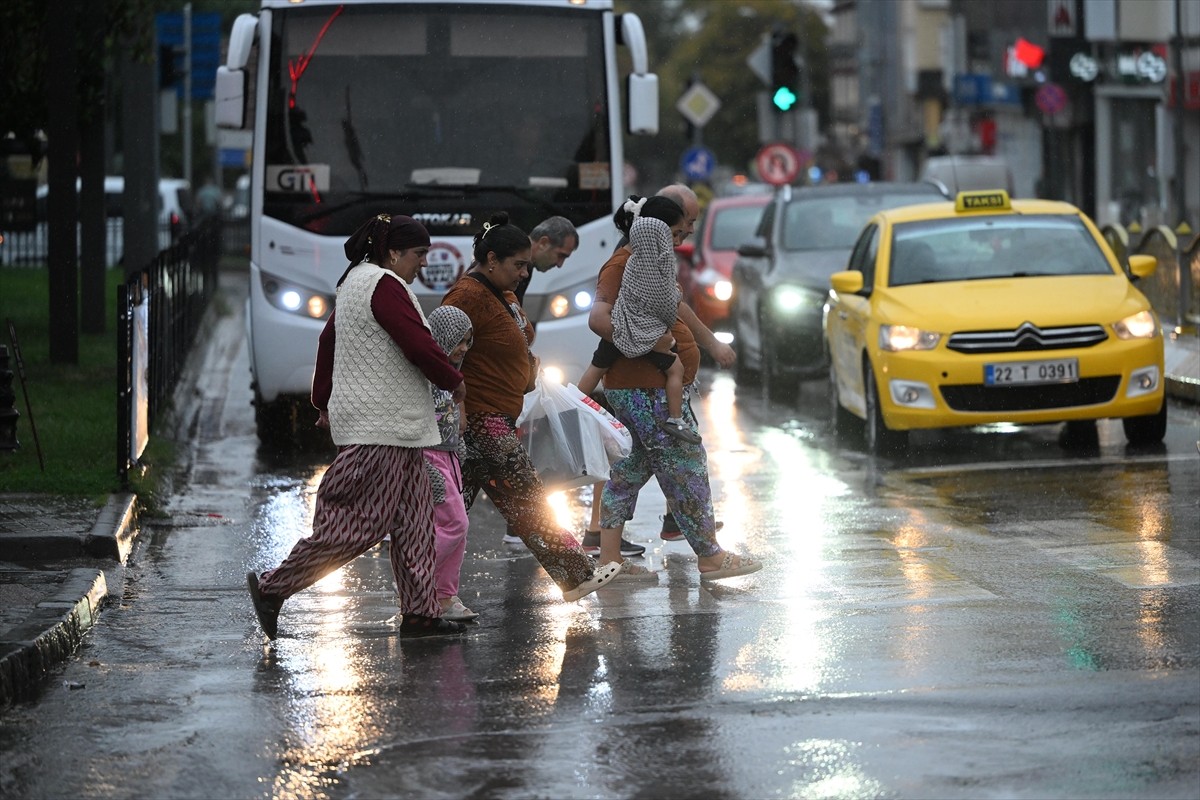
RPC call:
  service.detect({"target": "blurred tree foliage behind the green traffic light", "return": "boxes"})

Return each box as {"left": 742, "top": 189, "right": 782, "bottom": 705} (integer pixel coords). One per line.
{"left": 617, "top": 0, "right": 829, "bottom": 188}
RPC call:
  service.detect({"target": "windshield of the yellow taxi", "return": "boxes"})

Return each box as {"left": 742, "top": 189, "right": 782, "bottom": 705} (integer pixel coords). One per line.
{"left": 888, "top": 215, "right": 1112, "bottom": 287}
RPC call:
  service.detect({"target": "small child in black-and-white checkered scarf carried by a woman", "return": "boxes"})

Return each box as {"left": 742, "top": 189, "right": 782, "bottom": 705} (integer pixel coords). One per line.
{"left": 578, "top": 197, "right": 701, "bottom": 444}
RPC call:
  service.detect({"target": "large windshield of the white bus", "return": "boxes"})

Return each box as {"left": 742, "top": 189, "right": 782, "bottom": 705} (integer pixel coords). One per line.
{"left": 263, "top": 4, "right": 612, "bottom": 236}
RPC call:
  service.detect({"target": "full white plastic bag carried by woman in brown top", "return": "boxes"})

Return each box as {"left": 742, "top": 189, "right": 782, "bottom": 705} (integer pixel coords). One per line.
{"left": 517, "top": 375, "right": 632, "bottom": 491}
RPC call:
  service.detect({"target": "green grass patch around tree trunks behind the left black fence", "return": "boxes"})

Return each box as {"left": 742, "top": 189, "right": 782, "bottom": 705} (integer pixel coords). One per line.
{"left": 0, "top": 267, "right": 124, "bottom": 503}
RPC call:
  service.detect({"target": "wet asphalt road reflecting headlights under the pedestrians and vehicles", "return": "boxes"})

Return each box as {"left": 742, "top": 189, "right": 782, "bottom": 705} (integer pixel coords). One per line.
{"left": 0, "top": 277, "right": 1200, "bottom": 799}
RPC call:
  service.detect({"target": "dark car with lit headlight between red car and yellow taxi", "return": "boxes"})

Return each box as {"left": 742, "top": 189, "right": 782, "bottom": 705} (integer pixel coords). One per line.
{"left": 730, "top": 182, "right": 946, "bottom": 396}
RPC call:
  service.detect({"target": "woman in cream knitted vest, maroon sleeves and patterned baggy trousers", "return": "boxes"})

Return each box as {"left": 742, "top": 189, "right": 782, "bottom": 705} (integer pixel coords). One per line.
{"left": 246, "top": 215, "right": 467, "bottom": 639}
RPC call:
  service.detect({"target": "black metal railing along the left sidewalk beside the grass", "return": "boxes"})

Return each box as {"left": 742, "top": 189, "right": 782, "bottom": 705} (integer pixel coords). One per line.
{"left": 116, "top": 218, "right": 222, "bottom": 487}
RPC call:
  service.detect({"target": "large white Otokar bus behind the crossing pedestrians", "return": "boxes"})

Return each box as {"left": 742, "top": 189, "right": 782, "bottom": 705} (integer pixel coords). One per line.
{"left": 216, "top": 0, "right": 658, "bottom": 441}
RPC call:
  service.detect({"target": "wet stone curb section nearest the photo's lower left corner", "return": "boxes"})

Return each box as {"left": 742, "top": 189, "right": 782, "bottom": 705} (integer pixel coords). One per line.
{"left": 0, "top": 567, "right": 108, "bottom": 709}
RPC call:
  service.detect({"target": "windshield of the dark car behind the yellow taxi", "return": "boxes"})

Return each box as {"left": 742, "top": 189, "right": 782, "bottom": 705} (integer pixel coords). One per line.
{"left": 781, "top": 187, "right": 943, "bottom": 251}
